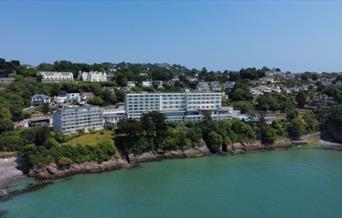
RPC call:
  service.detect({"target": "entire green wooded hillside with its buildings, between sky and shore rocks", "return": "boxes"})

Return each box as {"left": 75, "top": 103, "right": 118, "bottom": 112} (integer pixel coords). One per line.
{"left": 0, "top": 59, "right": 342, "bottom": 177}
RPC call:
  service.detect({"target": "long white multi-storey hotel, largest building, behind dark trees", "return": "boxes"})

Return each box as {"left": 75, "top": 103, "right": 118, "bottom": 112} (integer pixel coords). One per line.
{"left": 125, "top": 92, "right": 241, "bottom": 121}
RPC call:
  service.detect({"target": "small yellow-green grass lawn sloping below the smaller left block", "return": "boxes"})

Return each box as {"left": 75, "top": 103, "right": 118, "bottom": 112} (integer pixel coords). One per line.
{"left": 64, "top": 130, "right": 113, "bottom": 145}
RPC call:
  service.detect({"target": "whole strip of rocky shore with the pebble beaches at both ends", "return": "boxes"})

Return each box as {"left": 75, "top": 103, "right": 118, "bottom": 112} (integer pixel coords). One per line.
{"left": 0, "top": 132, "right": 342, "bottom": 201}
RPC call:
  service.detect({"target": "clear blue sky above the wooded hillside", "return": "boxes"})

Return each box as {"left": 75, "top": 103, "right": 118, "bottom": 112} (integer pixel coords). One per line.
{"left": 0, "top": 0, "right": 342, "bottom": 72}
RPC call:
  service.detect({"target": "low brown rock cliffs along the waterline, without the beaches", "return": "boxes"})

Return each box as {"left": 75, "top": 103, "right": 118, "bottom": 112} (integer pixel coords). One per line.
{"left": 28, "top": 133, "right": 320, "bottom": 180}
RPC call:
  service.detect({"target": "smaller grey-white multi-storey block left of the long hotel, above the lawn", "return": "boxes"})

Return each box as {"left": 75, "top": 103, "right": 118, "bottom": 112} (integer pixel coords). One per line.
{"left": 53, "top": 106, "right": 103, "bottom": 134}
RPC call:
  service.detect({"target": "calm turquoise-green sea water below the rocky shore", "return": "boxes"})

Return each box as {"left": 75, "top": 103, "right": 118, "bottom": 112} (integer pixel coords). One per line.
{"left": 0, "top": 149, "right": 342, "bottom": 217}
